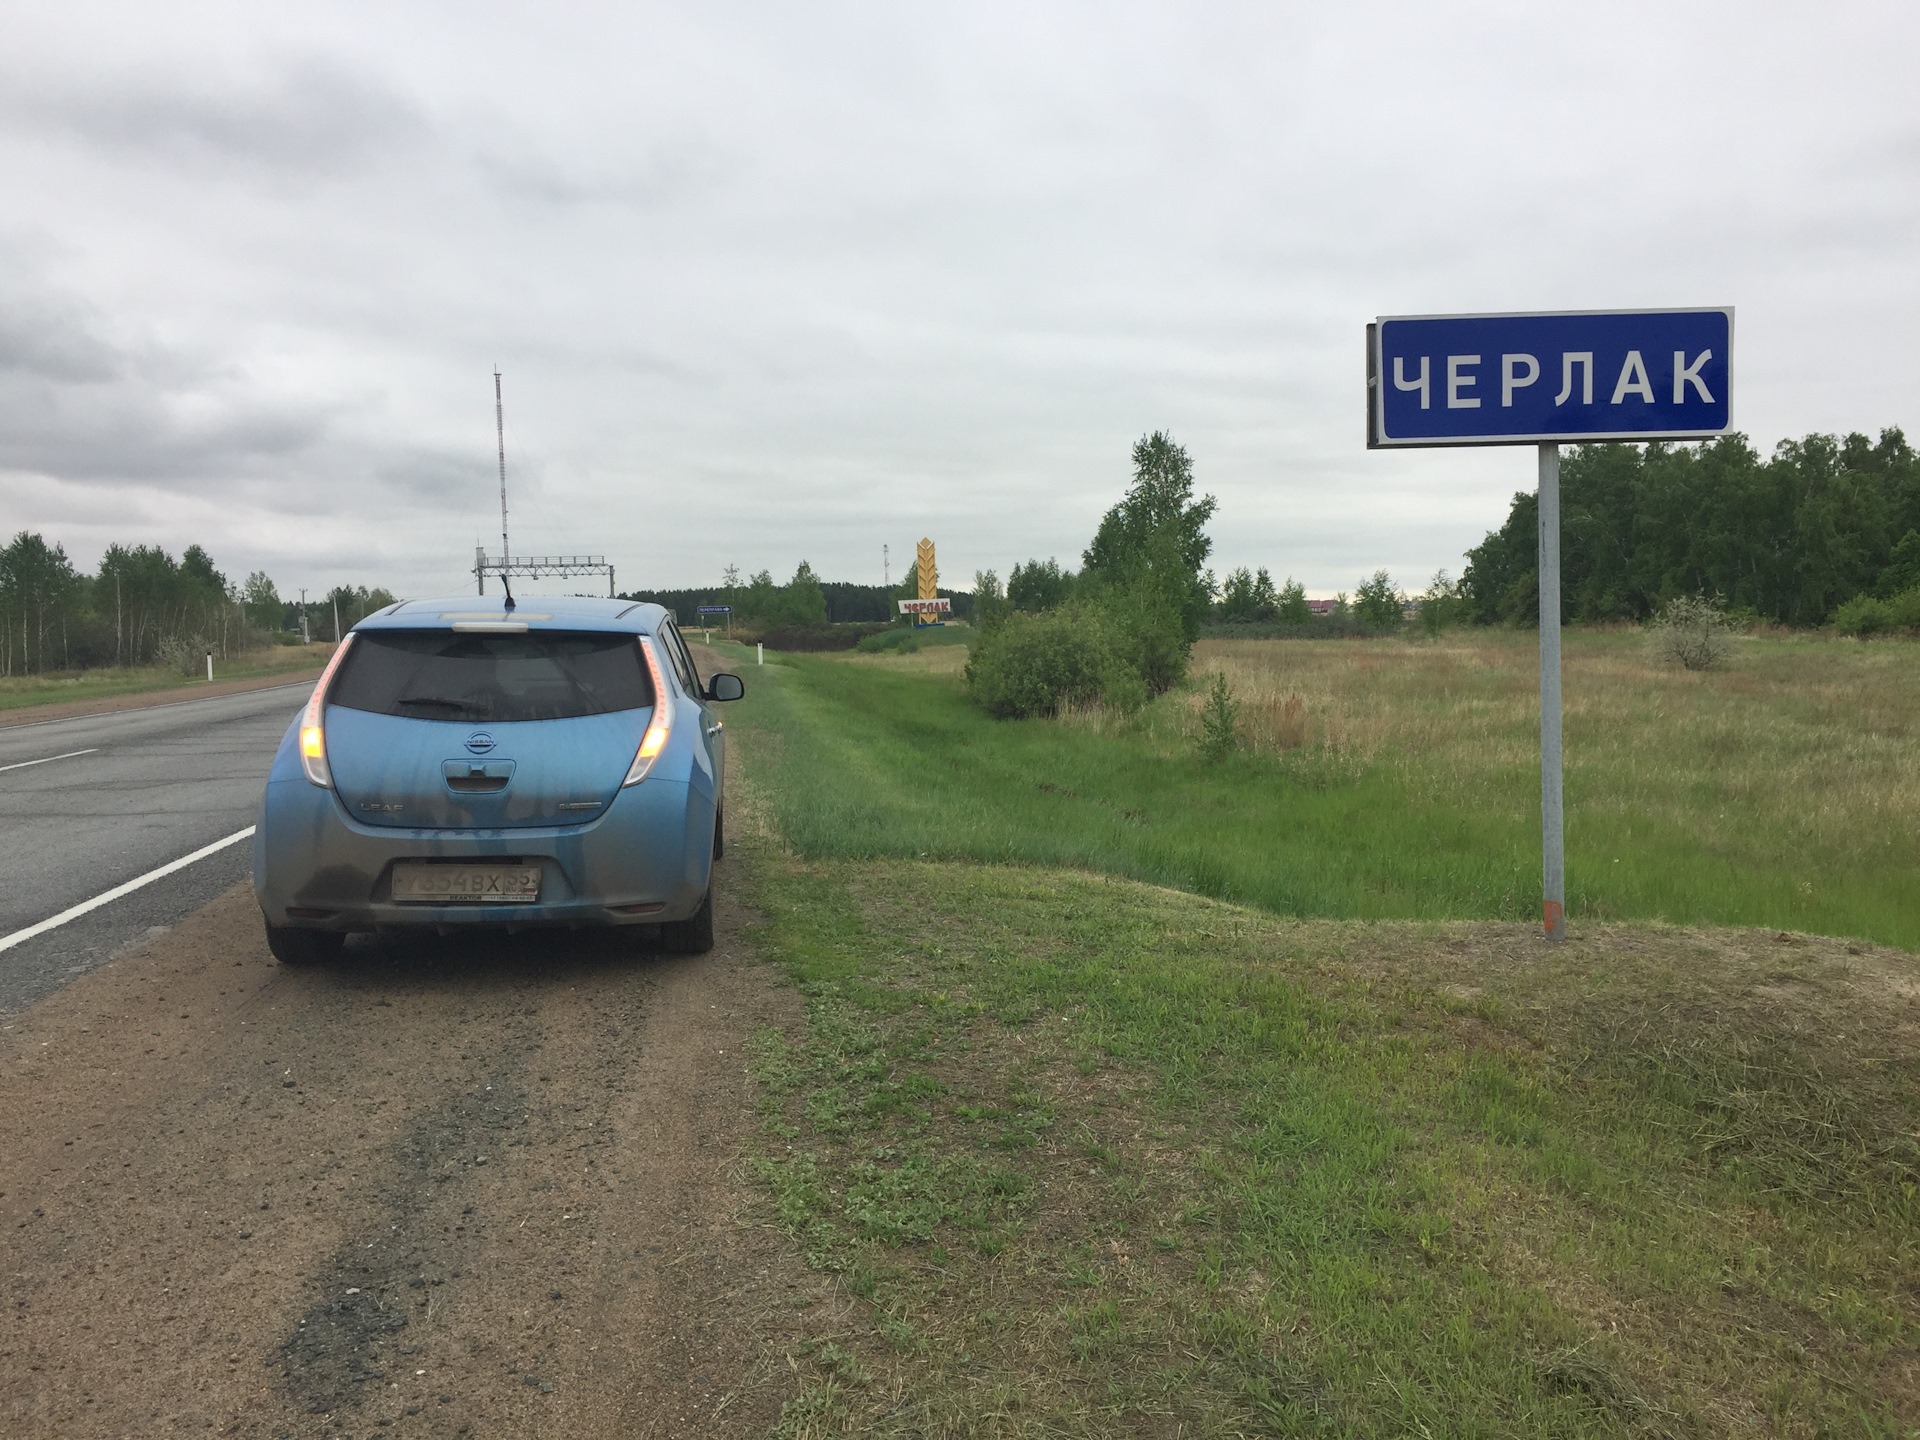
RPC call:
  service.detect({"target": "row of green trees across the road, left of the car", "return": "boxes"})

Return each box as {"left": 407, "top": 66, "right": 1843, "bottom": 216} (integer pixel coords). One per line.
{"left": 0, "top": 530, "right": 394, "bottom": 676}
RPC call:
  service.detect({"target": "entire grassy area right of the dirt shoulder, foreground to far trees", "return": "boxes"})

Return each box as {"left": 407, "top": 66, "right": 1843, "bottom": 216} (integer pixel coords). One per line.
{"left": 728, "top": 634, "right": 1920, "bottom": 1440}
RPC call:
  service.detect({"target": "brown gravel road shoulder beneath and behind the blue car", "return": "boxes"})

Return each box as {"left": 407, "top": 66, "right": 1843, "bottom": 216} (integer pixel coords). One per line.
{"left": 0, "top": 868, "right": 829, "bottom": 1438}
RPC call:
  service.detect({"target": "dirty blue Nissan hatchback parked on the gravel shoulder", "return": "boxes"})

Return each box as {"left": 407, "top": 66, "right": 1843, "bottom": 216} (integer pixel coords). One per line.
{"left": 253, "top": 595, "right": 745, "bottom": 966}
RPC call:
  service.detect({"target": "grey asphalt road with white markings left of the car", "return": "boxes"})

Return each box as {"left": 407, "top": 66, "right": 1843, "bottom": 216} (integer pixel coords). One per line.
{"left": 0, "top": 682, "right": 311, "bottom": 1014}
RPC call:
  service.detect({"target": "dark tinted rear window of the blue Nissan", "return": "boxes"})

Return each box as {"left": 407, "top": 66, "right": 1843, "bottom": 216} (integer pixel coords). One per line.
{"left": 326, "top": 630, "right": 653, "bottom": 722}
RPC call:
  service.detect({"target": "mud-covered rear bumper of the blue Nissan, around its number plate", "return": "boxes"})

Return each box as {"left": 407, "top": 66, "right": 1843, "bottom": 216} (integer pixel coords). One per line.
{"left": 253, "top": 778, "right": 714, "bottom": 931}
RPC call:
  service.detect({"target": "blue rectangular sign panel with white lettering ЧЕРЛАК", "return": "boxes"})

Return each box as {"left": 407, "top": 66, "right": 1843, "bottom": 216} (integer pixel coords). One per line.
{"left": 1367, "top": 305, "right": 1734, "bottom": 449}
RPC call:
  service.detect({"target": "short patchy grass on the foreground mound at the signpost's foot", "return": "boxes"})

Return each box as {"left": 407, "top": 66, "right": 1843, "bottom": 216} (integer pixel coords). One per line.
{"left": 741, "top": 852, "right": 1920, "bottom": 1436}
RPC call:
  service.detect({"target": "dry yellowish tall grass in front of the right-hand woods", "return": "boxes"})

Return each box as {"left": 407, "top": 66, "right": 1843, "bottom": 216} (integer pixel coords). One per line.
{"left": 1183, "top": 630, "right": 1920, "bottom": 879}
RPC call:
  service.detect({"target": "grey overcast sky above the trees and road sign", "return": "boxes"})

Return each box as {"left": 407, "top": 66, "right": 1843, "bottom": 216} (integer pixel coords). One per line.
{"left": 0, "top": 0, "right": 1920, "bottom": 593}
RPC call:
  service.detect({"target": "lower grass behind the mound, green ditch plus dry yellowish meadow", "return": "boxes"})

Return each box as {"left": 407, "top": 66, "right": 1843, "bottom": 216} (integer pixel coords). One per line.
{"left": 730, "top": 632, "right": 1920, "bottom": 950}
